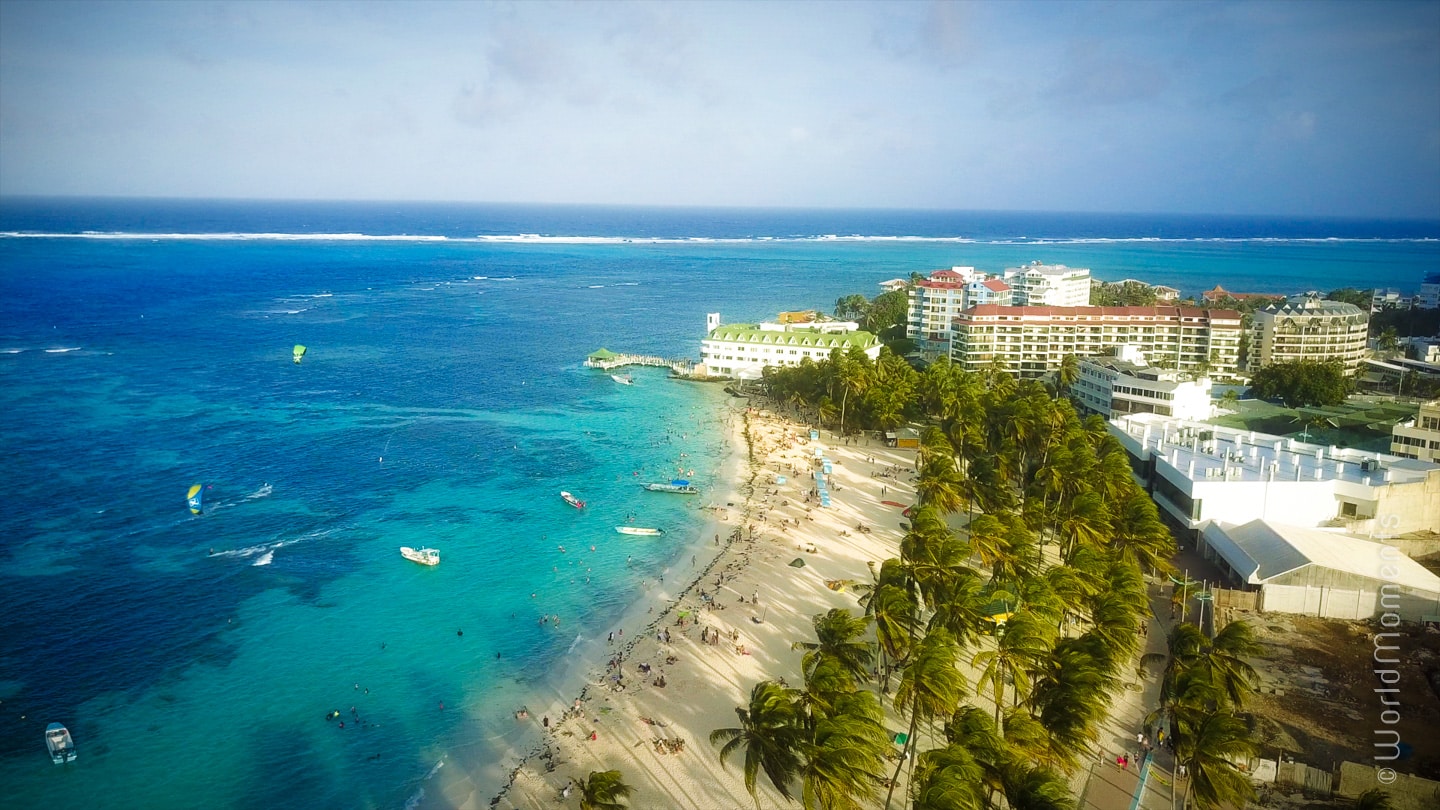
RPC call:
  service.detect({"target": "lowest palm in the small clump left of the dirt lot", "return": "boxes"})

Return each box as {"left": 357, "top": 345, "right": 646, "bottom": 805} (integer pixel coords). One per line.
{"left": 1175, "top": 709, "right": 1259, "bottom": 810}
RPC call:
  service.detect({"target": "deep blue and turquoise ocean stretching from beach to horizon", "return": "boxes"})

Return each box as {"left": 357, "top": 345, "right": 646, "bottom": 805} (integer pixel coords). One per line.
{"left": 0, "top": 199, "right": 1440, "bottom": 809}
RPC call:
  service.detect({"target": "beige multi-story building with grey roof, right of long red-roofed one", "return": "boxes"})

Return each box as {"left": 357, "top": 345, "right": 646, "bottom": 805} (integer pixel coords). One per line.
{"left": 1246, "top": 295, "right": 1369, "bottom": 373}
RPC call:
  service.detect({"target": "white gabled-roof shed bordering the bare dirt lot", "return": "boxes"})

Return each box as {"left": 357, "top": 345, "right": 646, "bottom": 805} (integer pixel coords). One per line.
{"left": 1198, "top": 520, "right": 1440, "bottom": 621}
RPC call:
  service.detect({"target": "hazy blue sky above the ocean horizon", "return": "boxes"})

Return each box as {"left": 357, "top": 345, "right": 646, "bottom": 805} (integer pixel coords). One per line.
{"left": 0, "top": 0, "right": 1440, "bottom": 219}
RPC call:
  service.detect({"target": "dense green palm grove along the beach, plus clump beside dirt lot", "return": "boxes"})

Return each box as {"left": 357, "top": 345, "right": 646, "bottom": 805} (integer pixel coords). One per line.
{"left": 711, "top": 350, "right": 1253, "bottom": 810}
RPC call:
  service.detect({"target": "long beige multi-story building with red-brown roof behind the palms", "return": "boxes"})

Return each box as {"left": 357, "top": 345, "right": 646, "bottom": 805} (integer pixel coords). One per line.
{"left": 950, "top": 306, "right": 1240, "bottom": 379}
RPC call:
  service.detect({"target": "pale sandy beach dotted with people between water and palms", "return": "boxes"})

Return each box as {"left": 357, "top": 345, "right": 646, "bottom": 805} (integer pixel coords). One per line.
{"left": 478, "top": 401, "right": 913, "bottom": 809}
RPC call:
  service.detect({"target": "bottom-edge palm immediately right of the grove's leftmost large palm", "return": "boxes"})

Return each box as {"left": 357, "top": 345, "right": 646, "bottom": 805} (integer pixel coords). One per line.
{"left": 801, "top": 690, "right": 890, "bottom": 810}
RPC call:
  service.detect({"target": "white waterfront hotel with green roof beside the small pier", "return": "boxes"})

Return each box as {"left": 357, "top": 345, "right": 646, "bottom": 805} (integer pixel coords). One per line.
{"left": 700, "top": 314, "right": 881, "bottom": 379}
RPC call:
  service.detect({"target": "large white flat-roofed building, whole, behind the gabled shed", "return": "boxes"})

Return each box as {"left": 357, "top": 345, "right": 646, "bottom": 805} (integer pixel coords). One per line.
{"left": 1109, "top": 414, "right": 1440, "bottom": 535}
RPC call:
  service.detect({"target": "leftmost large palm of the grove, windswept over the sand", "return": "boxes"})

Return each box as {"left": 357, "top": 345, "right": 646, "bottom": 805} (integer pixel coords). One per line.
{"left": 710, "top": 680, "right": 805, "bottom": 809}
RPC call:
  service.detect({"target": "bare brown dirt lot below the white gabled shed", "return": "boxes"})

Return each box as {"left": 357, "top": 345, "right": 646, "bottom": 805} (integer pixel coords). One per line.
{"left": 1234, "top": 614, "right": 1440, "bottom": 780}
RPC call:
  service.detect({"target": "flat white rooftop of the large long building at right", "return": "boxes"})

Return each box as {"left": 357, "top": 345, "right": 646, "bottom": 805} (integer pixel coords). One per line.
{"left": 1110, "top": 414, "right": 1440, "bottom": 486}
